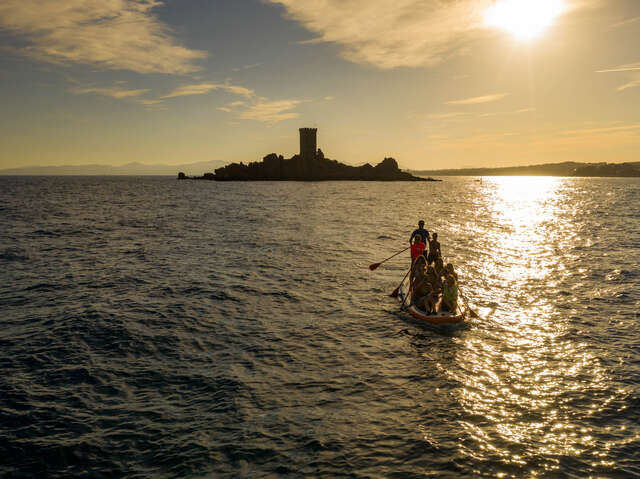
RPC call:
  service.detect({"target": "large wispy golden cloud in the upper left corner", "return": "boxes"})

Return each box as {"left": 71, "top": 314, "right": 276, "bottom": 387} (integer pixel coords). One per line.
{"left": 0, "top": 0, "right": 206, "bottom": 74}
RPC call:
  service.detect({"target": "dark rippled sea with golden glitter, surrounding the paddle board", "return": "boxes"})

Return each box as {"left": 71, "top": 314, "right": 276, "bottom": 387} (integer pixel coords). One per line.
{"left": 0, "top": 177, "right": 640, "bottom": 479}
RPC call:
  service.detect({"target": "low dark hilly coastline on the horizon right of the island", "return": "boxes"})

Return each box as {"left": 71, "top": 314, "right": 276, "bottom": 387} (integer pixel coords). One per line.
{"left": 411, "top": 161, "right": 640, "bottom": 177}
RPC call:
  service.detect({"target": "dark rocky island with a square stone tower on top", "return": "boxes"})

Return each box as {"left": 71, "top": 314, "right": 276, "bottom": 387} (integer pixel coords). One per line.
{"left": 178, "top": 128, "right": 442, "bottom": 181}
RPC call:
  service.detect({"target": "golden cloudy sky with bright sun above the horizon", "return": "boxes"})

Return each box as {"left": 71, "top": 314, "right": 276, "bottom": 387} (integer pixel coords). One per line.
{"left": 0, "top": 0, "right": 640, "bottom": 169}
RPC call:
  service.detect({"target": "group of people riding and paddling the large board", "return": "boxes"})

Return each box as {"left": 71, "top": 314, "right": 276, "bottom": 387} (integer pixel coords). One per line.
{"left": 409, "top": 220, "right": 458, "bottom": 314}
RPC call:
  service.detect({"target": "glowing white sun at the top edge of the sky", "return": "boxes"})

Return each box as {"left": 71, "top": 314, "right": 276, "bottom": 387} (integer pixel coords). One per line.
{"left": 484, "top": 0, "right": 566, "bottom": 41}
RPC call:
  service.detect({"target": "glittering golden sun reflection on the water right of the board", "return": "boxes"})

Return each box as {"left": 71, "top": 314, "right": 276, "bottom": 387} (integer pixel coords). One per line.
{"left": 444, "top": 177, "right": 632, "bottom": 477}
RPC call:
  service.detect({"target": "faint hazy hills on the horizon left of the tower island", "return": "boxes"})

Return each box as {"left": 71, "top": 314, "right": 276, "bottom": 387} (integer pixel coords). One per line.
{"left": 0, "top": 160, "right": 229, "bottom": 176}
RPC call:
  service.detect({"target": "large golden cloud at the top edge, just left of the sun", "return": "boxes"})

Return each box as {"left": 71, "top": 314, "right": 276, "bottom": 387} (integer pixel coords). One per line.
{"left": 265, "top": 0, "right": 491, "bottom": 69}
